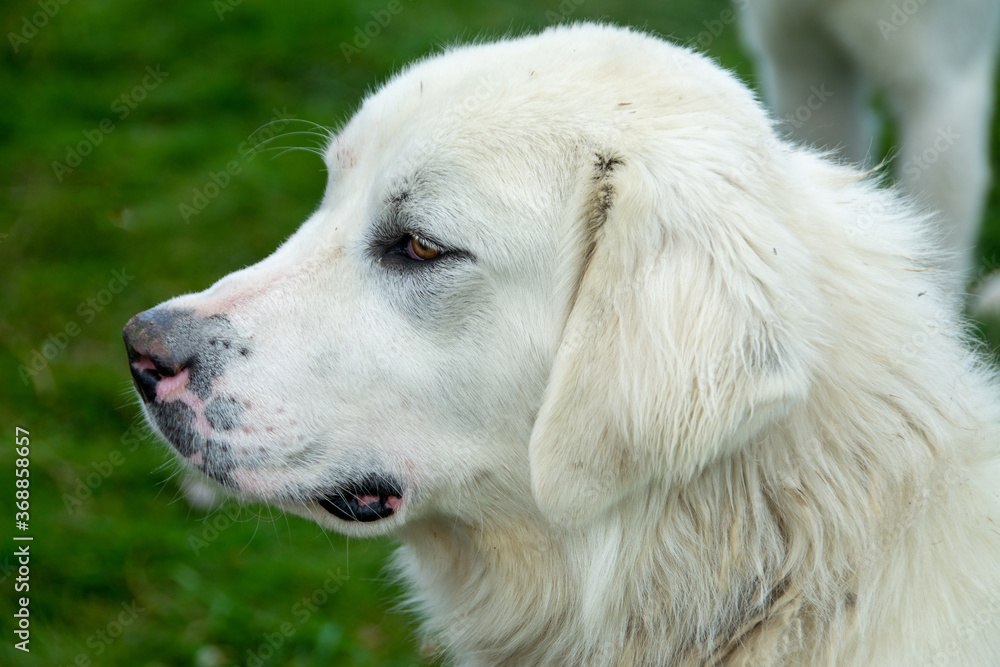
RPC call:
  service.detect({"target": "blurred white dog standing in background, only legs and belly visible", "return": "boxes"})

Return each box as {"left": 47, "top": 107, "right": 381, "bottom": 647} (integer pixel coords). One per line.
{"left": 735, "top": 0, "right": 1000, "bottom": 294}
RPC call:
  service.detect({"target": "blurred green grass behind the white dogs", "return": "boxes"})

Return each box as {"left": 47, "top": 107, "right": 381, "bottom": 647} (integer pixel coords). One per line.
{"left": 0, "top": 0, "right": 1000, "bottom": 667}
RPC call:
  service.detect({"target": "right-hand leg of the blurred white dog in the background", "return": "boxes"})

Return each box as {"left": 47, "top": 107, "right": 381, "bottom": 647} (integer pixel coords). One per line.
{"left": 874, "top": 2, "right": 1000, "bottom": 289}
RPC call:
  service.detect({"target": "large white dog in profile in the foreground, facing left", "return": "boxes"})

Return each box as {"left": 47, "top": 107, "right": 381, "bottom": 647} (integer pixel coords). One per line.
{"left": 124, "top": 25, "right": 1000, "bottom": 666}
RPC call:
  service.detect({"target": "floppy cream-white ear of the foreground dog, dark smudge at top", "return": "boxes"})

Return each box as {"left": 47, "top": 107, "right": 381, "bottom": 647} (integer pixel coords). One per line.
{"left": 530, "top": 151, "right": 809, "bottom": 523}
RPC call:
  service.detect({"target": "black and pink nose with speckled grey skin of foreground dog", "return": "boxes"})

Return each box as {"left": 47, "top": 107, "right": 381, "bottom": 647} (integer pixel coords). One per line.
{"left": 122, "top": 306, "right": 250, "bottom": 403}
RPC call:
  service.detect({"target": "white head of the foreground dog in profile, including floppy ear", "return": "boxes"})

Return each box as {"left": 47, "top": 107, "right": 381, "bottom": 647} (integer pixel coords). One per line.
{"left": 124, "top": 25, "right": 812, "bottom": 534}
